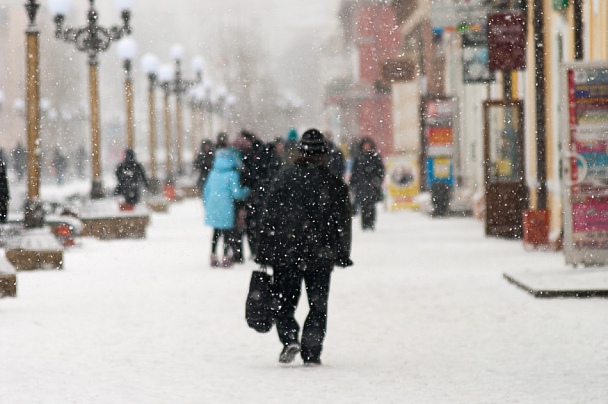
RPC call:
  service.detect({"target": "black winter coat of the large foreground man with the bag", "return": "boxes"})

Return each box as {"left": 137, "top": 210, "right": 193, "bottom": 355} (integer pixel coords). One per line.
{"left": 256, "top": 159, "right": 352, "bottom": 266}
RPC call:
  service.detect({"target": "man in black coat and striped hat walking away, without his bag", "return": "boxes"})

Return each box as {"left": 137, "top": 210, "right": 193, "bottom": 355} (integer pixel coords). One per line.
{"left": 256, "top": 129, "right": 353, "bottom": 365}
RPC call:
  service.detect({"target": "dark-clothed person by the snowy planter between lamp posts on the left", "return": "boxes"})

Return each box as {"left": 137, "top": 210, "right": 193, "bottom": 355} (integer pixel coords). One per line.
{"left": 114, "top": 149, "right": 150, "bottom": 209}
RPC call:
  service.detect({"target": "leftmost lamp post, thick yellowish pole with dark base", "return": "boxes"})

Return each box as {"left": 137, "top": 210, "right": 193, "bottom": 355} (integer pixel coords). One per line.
{"left": 25, "top": 0, "right": 44, "bottom": 228}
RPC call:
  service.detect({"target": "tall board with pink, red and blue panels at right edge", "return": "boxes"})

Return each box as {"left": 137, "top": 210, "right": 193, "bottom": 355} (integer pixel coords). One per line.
{"left": 562, "top": 63, "right": 608, "bottom": 265}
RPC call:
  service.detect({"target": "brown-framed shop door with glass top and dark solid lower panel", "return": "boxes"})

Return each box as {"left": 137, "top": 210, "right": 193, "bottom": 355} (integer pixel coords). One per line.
{"left": 484, "top": 100, "right": 529, "bottom": 238}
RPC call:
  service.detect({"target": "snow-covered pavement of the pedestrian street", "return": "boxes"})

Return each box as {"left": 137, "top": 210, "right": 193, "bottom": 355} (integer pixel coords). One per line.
{"left": 0, "top": 200, "right": 608, "bottom": 404}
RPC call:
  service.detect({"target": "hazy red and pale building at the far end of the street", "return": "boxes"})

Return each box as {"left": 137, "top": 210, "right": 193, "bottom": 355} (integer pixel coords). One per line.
{"left": 325, "top": 0, "right": 401, "bottom": 155}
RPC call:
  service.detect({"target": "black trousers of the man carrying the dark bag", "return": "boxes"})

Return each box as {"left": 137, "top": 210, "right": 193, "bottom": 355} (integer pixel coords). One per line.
{"left": 273, "top": 261, "right": 333, "bottom": 360}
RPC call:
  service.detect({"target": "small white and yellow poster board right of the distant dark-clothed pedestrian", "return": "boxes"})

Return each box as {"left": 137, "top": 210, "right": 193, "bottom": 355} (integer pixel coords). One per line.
{"left": 386, "top": 156, "right": 420, "bottom": 210}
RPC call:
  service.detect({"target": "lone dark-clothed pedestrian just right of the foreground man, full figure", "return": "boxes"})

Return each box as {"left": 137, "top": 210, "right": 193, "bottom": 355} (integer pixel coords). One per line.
{"left": 350, "top": 137, "right": 385, "bottom": 230}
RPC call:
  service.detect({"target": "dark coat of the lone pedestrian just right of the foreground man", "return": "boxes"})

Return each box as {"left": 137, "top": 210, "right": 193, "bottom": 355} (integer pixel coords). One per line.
{"left": 350, "top": 152, "right": 384, "bottom": 207}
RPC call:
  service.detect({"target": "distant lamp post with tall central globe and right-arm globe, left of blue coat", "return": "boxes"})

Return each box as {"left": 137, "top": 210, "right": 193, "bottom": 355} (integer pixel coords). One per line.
{"left": 171, "top": 44, "right": 204, "bottom": 175}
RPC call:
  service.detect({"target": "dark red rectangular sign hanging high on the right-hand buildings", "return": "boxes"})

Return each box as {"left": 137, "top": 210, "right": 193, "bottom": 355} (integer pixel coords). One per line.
{"left": 488, "top": 11, "right": 526, "bottom": 70}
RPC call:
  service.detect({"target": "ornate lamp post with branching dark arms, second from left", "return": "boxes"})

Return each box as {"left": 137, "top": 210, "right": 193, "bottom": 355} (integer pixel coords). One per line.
{"left": 49, "top": 0, "right": 135, "bottom": 199}
